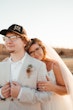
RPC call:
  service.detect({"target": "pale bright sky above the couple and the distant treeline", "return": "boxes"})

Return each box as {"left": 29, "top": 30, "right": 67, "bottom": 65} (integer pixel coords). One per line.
{"left": 0, "top": 0, "right": 73, "bottom": 48}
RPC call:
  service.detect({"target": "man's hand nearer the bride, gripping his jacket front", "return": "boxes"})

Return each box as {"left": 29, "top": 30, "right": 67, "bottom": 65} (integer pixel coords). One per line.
{"left": 11, "top": 81, "right": 21, "bottom": 98}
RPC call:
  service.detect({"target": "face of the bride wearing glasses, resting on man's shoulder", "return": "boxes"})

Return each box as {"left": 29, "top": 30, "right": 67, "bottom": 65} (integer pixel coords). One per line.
{"left": 29, "top": 43, "right": 44, "bottom": 60}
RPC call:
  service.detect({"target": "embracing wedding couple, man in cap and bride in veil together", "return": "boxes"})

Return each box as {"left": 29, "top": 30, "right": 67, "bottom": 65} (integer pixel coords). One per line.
{"left": 0, "top": 24, "right": 73, "bottom": 110}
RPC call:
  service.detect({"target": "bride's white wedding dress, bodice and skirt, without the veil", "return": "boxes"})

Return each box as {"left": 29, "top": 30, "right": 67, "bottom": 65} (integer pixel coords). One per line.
{"left": 41, "top": 70, "right": 73, "bottom": 110}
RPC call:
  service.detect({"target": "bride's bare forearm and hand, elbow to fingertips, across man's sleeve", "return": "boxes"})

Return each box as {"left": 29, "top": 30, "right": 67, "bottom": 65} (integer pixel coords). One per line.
{"left": 38, "top": 77, "right": 67, "bottom": 95}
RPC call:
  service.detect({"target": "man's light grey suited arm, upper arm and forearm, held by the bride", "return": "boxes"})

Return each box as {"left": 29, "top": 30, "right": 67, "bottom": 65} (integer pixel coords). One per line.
{"left": 18, "top": 63, "right": 52, "bottom": 103}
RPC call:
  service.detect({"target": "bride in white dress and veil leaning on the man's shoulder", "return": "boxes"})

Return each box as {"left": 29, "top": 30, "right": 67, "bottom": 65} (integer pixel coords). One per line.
{"left": 26, "top": 38, "right": 73, "bottom": 110}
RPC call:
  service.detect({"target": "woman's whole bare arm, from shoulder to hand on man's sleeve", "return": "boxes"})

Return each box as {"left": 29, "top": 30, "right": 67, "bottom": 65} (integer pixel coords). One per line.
{"left": 38, "top": 59, "right": 67, "bottom": 95}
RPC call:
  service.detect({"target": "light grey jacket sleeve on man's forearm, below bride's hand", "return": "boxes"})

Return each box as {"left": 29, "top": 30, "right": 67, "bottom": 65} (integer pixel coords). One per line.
{"left": 18, "top": 87, "right": 52, "bottom": 104}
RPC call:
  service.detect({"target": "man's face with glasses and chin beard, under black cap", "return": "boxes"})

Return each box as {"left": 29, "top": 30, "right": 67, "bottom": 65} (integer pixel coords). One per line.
{"left": 4, "top": 33, "right": 25, "bottom": 53}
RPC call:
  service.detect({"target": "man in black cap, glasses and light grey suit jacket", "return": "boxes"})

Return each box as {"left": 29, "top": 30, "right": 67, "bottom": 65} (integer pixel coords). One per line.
{"left": 0, "top": 24, "right": 49, "bottom": 110}
